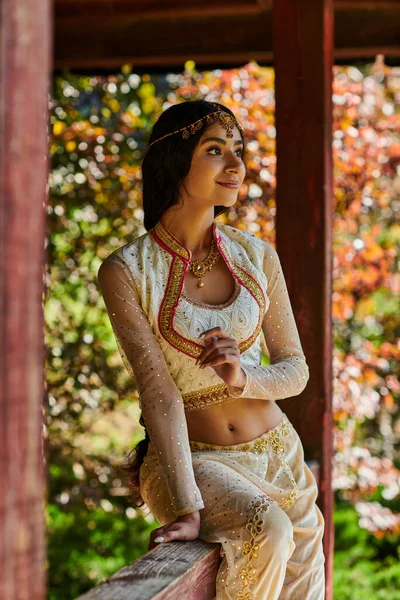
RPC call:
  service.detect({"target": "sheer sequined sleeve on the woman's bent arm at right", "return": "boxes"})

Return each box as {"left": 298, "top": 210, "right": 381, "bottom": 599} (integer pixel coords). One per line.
{"left": 229, "top": 242, "right": 309, "bottom": 400}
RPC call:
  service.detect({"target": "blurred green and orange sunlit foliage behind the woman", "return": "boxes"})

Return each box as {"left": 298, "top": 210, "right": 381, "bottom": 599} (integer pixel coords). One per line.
{"left": 45, "top": 56, "right": 400, "bottom": 600}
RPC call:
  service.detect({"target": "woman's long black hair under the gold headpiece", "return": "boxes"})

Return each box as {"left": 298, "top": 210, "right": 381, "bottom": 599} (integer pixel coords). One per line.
{"left": 122, "top": 100, "right": 245, "bottom": 506}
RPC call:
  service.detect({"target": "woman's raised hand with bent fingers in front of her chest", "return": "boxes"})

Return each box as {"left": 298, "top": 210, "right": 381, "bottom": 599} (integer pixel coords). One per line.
{"left": 196, "top": 327, "right": 246, "bottom": 388}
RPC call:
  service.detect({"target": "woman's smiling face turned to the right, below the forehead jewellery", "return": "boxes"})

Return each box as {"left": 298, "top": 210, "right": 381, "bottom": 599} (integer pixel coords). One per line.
{"left": 181, "top": 122, "right": 246, "bottom": 208}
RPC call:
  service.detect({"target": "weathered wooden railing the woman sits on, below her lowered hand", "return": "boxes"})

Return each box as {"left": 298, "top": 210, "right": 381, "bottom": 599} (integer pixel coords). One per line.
{"left": 76, "top": 460, "right": 319, "bottom": 600}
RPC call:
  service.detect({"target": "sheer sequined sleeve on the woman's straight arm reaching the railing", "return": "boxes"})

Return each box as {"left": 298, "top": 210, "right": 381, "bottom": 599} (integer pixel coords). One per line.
{"left": 98, "top": 255, "right": 204, "bottom": 516}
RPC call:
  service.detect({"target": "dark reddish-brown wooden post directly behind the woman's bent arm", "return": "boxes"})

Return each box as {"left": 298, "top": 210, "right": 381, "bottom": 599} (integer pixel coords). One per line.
{"left": 273, "top": 0, "right": 334, "bottom": 600}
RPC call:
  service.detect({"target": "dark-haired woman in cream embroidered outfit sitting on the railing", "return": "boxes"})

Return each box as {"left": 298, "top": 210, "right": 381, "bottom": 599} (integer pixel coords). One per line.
{"left": 98, "top": 101, "right": 325, "bottom": 600}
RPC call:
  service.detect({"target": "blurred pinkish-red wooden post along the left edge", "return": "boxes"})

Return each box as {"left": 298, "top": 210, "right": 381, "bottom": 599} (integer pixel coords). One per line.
{"left": 0, "top": 0, "right": 51, "bottom": 600}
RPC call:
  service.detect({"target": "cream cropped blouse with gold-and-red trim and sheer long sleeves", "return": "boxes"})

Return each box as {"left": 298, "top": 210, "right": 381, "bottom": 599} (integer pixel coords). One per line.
{"left": 98, "top": 220, "right": 309, "bottom": 516}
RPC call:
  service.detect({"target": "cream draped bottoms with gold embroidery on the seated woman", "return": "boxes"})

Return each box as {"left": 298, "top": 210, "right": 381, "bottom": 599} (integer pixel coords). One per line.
{"left": 140, "top": 413, "right": 325, "bottom": 600}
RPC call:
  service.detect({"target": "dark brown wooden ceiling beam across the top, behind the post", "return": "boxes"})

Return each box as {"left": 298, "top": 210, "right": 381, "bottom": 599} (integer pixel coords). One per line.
{"left": 54, "top": 0, "right": 400, "bottom": 72}
